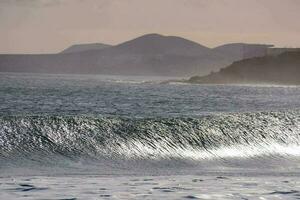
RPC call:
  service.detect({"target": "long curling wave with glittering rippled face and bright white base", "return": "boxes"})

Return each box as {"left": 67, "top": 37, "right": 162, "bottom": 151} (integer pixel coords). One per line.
{"left": 0, "top": 112, "right": 300, "bottom": 167}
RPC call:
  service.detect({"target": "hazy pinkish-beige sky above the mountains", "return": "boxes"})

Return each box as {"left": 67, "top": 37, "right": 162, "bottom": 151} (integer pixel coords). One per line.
{"left": 0, "top": 0, "right": 300, "bottom": 53}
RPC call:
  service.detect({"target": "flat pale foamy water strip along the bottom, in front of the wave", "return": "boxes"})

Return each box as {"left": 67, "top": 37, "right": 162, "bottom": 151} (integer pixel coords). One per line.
{"left": 0, "top": 174, "right": 300, "bottom": 199}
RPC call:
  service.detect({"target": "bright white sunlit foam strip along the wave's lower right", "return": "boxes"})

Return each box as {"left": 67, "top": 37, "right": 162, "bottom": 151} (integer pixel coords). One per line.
{"left": 117, "top": 140, "right": 300, "bottom": 160}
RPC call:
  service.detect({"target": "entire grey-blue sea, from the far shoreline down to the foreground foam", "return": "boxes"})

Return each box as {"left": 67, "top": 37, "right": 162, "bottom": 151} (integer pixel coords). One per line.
{"left": 0, "top": 73, "right": 300, "bottom": 200}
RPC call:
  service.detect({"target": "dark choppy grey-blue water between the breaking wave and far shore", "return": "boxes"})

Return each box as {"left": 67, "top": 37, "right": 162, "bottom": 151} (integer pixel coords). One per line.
{"left": 0, "top": 74, "right": 300, "bottom": 118}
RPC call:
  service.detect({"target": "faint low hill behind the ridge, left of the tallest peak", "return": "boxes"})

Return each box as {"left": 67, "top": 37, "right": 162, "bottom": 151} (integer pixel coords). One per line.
{"left": 60, "top": 43, "right": 111, "bottom": 53}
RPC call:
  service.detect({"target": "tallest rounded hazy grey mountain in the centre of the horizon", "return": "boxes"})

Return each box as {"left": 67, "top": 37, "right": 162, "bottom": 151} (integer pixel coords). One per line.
{"left": 82, "top": 34, "right": 229, "bottom": 76}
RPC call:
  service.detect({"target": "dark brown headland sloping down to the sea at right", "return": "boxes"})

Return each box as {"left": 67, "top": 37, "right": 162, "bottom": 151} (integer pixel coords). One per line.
{"left": 188, "top": 51, "right": 300, "bottom": 85}
